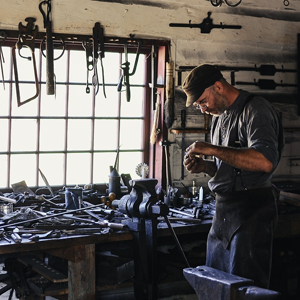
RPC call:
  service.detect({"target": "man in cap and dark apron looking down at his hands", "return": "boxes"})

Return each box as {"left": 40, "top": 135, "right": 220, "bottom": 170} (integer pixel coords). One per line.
{"left": 182, "top": 64, "right": 284, "bottom": 288}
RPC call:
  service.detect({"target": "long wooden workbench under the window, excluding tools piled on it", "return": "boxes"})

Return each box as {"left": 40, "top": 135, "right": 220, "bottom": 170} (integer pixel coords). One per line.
{"left": 0, "top": 213, "right": 300, "bottom": 300}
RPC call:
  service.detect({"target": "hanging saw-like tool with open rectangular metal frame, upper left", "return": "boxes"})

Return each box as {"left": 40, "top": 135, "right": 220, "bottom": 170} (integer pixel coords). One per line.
{"left": 12, "top": 17, "right": 40, "bottom": 106}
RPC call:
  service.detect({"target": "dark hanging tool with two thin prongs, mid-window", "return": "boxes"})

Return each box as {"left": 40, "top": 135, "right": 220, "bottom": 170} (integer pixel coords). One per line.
{"left": 92, "top": 22, "right": 106, "bottom": 98}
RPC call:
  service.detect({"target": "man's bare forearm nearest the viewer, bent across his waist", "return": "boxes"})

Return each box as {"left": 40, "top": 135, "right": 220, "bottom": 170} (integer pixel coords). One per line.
{"left": 186, "top": 142, "right": 273, "bottom": 173}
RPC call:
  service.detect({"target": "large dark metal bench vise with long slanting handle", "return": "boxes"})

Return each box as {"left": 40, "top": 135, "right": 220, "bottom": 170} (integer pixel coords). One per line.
{"left": 113, "top": 178, "right": 189, "bottom": 300}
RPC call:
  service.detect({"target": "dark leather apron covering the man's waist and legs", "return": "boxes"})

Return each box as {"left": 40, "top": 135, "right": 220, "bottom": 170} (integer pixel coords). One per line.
{"left": 206, "top": 187, "right": 277, "bottom": 288}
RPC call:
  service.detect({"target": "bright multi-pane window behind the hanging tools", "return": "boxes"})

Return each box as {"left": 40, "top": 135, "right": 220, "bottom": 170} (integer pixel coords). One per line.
{"left": 0, "top": 38, "right": 155, "bottom": 188}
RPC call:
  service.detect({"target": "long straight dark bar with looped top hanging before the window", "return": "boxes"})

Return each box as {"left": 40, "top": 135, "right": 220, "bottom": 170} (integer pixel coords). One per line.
{"left": 39, "top": 0, "right": 55, "bottom": 95}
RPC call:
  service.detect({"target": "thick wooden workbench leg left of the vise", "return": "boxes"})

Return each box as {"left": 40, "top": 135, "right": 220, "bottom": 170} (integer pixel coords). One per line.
{"left": 68, "top": 244, "right": 96, "bottom": 300}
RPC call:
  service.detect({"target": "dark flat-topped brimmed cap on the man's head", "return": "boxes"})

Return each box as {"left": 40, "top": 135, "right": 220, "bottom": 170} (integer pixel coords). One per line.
{"left": 182, "top": 64, "right": 223, "bottom": 107}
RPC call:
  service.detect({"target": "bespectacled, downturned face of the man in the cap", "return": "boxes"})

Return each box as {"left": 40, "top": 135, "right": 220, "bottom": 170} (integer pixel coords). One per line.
{"left": 193, "top": 86, "right": 228, "bottom": 116}
